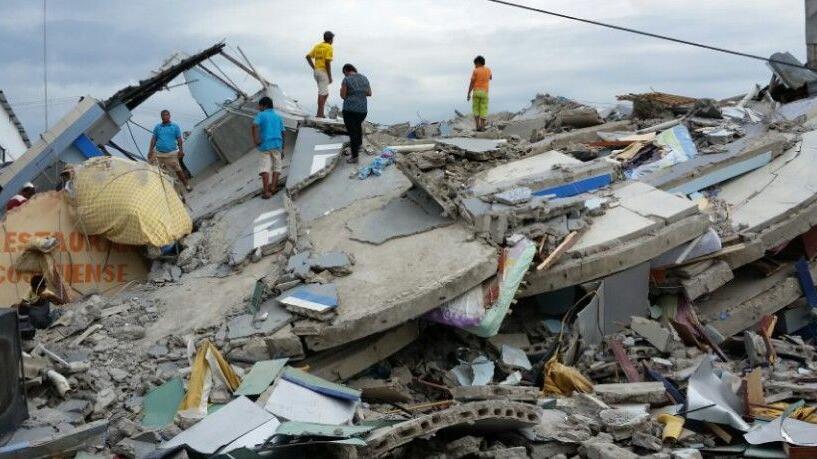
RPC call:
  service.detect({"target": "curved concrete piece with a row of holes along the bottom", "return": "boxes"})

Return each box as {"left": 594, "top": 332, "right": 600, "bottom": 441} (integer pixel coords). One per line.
{"left": 364, "top": 400, "right": 539, "bottom": 457}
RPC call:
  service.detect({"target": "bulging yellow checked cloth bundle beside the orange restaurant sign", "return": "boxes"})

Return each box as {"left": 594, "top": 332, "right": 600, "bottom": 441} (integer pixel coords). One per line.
{"left": 70, "top": 157, "right": 193, "bottom": 247}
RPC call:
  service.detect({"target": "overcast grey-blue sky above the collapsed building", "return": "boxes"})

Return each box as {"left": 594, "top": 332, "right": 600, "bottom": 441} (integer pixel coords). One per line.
{"left": 0, "top": 0, "right": 805, "bottom": 153}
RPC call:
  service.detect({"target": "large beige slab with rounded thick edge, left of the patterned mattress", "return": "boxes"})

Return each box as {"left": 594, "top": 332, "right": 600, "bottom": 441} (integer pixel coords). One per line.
{"left": 304, "top": 221, "right": 497, "bottom": 351}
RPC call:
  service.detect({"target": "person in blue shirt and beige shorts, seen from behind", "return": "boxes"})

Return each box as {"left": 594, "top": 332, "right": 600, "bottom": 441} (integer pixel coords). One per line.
{"left": 252, "top": 97, "right": 284, "bottom": 199}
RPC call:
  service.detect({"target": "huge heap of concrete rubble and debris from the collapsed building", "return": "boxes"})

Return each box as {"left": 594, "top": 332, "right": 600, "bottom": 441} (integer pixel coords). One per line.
{"left": 0, "top": 44, "right": 817, "bottom": 458}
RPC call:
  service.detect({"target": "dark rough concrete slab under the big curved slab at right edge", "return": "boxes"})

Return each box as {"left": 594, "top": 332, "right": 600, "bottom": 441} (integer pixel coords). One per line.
{"left": 695, "top": 262, "right": 817, "bottom": 337}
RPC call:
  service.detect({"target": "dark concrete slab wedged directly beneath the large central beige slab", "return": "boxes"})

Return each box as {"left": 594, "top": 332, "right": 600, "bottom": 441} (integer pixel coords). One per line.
{"left": 305, "top": 321, "right": 420, "bottom": 381}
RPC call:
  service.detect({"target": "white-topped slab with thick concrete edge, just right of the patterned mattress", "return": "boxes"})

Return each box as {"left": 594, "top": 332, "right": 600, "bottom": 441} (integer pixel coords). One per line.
{"left": 522, "top": 182, "right": 709, "bottom": 296}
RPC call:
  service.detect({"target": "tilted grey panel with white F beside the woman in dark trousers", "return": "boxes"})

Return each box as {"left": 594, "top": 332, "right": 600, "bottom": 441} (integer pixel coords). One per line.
{"left": 286, "top": 127, "right": 349, "bottom": 194}
